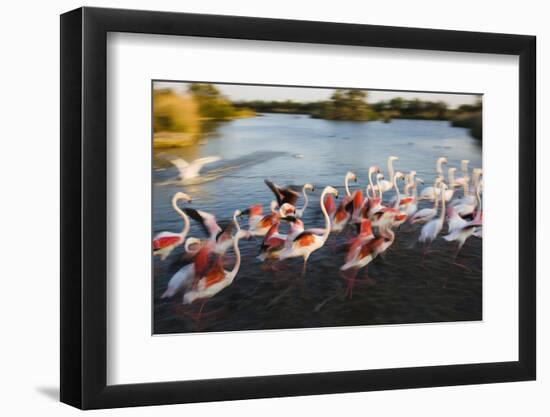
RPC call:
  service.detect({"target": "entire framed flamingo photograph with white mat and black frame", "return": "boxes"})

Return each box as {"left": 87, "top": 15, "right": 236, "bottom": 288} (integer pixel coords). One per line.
{"left": 61, "top": 7, "right": 536, "bottom": 409}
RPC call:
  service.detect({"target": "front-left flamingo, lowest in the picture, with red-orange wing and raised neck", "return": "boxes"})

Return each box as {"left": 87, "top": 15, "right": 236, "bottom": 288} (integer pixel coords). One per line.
{"left": 183, "top": 230, "right": 250, "bottom": 306}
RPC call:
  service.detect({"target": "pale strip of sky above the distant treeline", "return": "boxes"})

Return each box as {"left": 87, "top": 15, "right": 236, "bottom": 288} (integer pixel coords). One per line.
{"left": 154, "top": 81, "right": 480, "bottom": 108}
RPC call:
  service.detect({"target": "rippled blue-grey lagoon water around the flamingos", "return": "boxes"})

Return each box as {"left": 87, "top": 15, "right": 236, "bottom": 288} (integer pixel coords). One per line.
{"left": 153, "top": 114, "right": 482, "bottom": 334}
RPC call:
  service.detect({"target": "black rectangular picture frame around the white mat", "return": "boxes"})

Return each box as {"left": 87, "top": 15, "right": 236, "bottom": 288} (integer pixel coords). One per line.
{"left": 60, "top": 7, "right": 536, "bottom": 409}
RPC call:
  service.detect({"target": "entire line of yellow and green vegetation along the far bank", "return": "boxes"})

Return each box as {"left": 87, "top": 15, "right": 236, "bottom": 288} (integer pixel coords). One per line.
{"left": 153, "top": 83, "right": 482, "bottom": 147}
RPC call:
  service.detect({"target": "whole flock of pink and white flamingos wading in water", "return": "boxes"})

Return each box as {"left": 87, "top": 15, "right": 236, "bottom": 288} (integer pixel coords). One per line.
{"left": 153, "top": 156, "right": 483, "bottom": 315}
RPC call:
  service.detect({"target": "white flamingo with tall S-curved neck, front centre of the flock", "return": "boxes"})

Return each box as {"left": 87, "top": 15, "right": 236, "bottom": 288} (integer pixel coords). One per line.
{"left": 279, "top": 185, "right": 338, "bottom": 277}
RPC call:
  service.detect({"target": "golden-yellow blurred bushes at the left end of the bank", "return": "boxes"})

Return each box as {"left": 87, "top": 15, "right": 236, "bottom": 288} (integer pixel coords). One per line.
{"left": 153, "top": 83, "right": 256, "bottom": 147}
